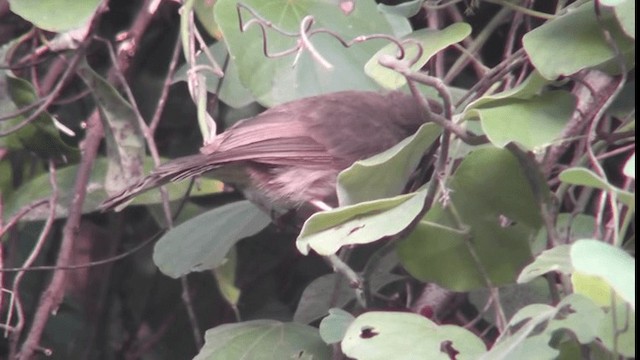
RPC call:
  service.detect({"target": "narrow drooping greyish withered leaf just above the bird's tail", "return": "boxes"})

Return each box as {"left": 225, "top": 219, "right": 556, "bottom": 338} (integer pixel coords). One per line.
{"left": 77, "top": 62, "right": 145, "bottom": 195}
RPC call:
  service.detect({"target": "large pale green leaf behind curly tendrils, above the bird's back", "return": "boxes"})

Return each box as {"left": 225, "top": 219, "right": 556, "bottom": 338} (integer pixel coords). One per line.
{"left": 214, "top": 0, "right": 406, "bottom": 107}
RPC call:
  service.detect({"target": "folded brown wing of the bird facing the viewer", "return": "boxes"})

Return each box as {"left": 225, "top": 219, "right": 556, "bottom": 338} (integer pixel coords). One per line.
{"left": 195, "top": 91, "right": 423, "bottom": 168}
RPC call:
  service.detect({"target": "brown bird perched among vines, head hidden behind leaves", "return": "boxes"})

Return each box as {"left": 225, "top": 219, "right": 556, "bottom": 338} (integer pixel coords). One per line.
{"left": 101, "top": 91, "right": 439, "bottom": 211}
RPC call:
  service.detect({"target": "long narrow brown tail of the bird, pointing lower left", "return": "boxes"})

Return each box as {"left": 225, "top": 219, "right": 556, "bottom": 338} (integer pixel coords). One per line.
{"left": 98, "top": 154, "right": 220, "bottom": 211}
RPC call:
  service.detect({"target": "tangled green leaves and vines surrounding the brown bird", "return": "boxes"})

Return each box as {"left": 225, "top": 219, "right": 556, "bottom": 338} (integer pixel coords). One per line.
{"left": 0, "top": 0, "right": 635, "bottom": 360}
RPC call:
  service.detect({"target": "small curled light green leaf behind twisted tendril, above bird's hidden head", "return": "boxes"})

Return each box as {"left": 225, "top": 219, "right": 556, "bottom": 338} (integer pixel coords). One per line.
{"left": 364, "top": 23, "right": 471, "bottom": 90}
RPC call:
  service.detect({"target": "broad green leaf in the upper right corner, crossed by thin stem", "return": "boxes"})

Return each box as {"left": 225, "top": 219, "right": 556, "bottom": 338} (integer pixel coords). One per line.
{"left": 522, "top": 1, "right": 635, "bottom": 79}
